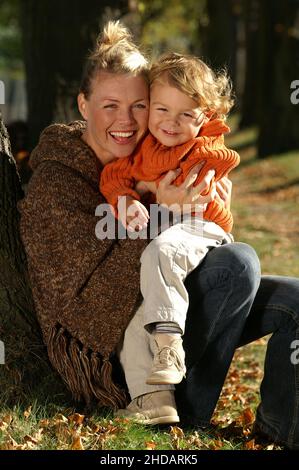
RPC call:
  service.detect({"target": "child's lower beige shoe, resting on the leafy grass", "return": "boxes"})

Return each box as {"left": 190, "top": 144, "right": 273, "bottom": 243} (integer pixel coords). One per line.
{"left": 114, "top": 390, "right": 180, "bottom": 424}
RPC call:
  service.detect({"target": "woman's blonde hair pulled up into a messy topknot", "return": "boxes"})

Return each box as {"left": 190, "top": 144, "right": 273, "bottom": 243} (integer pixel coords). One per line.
{"left": 80, "top": 21, "right": 149, "bottom": 98}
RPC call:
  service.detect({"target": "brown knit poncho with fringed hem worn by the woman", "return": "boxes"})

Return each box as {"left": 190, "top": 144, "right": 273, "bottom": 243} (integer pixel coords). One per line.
{"left": 19, "top": 121, "right": 148, "bottom": 407}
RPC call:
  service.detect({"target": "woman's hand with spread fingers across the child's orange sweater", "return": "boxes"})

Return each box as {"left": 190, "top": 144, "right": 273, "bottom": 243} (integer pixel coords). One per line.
{"left": 156, "top": 162, "right": 216, "bottom": 211}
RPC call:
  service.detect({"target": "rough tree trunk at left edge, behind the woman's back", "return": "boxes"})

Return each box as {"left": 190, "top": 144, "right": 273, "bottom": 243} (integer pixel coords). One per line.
{"left": 0, "top": 114, "right": 65, "bottom": 402}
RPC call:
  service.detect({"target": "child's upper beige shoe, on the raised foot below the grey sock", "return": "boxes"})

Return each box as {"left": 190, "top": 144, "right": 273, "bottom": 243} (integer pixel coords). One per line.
{"left": 146, "top": 334, "right": 186, "bottom": 385}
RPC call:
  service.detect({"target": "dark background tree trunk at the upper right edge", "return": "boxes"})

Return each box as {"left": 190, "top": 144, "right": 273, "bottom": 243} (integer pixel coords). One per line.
{"left": 258, "top": 0, "right": 299, "bottom": 157}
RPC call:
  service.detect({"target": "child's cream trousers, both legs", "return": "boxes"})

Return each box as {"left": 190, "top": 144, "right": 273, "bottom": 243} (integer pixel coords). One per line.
{"left": 119, "top": 218, "right": 233, "bottom": 400}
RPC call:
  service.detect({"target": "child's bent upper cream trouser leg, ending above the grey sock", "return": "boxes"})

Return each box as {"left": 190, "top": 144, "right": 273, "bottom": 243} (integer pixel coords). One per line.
{"left": 140, "top": 216, "right": 232, "bottom": 334}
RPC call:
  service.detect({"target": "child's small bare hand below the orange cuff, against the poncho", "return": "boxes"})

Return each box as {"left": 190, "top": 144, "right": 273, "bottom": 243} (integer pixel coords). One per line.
{"left": 118, "top": 196, "right": 149, "bottom": 232}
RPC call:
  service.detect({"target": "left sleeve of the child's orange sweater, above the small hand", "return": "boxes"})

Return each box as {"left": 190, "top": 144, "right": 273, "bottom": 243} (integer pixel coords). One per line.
{"left": 100, "top": 157, "right": 140, "bottom": 211}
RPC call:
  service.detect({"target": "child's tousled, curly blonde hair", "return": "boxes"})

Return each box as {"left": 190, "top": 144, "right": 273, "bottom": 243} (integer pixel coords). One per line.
{"left": 149, "top": 52, "right": 234, "bottom": 118}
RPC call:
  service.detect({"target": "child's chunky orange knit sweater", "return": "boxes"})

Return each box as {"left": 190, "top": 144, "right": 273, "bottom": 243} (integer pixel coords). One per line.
{"left": 100, "top": 119, "right": 240, "bottom": 232}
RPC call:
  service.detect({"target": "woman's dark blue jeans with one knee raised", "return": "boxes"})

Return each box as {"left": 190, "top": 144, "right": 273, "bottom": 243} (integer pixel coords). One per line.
{"left": 176, "top": 243, "right": 299, "bottom": 449}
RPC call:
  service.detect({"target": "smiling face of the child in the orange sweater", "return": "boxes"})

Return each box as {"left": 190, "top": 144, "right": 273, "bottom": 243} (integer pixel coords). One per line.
{"left": 148, "top": 82, "right": 206, "bottom": 147}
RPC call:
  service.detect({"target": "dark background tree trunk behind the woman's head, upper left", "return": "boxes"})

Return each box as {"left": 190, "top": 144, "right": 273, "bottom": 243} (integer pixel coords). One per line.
{"left": 20, "top": 0, "right": 127, "bottom": 147}
